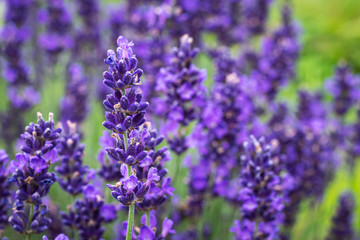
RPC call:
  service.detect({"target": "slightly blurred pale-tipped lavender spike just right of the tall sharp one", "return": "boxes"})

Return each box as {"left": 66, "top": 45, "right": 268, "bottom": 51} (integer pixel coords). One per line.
{"left": 156, "top": 35, "right": 206, "bottom": 155}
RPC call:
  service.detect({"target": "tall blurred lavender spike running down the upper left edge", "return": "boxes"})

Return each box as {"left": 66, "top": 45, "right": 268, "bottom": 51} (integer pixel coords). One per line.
{"left": 1, "top": 0, "right": 40, "bottom": 152}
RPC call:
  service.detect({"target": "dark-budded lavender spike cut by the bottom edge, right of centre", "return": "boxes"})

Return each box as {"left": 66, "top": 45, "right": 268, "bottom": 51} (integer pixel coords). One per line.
{"left": 231, "top": 137, "right": 284, "bottom": 239}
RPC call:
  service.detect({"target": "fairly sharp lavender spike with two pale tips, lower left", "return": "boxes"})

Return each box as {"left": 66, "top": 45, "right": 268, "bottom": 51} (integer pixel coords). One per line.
{"left": 9, "top": 113, "right": 61, "bottom": 235}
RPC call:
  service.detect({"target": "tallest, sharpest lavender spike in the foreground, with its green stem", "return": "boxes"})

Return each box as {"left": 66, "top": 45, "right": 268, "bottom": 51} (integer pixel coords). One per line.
{"left": 103, "top": 36, "right": 173, "bottom": 240}
